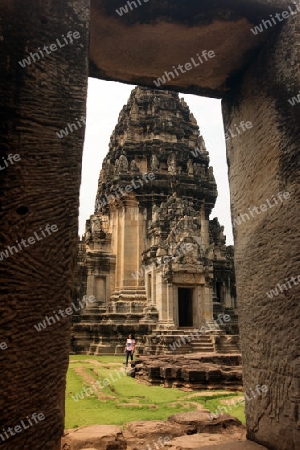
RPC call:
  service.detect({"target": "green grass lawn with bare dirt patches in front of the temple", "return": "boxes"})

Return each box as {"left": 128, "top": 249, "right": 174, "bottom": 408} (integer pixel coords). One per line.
{"left": 65, "top": 355, "right": 244, "bottom": 428}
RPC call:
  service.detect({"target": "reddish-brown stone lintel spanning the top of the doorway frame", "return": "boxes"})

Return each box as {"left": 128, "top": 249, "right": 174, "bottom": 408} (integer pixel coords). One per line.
{"left": 90, "top": 0, "right": 297, "bottom": 97}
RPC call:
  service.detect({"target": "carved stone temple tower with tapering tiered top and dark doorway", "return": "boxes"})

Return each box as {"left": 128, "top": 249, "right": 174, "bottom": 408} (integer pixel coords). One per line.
{"left": 72, "top": 87, "right": 237, "bottom": 353}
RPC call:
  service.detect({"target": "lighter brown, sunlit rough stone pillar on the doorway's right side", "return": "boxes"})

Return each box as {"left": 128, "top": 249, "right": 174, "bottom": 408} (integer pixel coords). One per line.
{"left": 223, "top": 14, "right": 300, "bottom": 450}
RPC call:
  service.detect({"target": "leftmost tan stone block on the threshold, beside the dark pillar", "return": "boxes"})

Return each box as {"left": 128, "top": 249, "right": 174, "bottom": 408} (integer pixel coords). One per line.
{"left": 62, "top": 425, "right": 126, "bottom": 450}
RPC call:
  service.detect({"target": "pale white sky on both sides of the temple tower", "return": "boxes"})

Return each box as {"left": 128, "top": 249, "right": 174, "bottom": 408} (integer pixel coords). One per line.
{"left": 79, "top": 78, "right": 233, "bottom": 245}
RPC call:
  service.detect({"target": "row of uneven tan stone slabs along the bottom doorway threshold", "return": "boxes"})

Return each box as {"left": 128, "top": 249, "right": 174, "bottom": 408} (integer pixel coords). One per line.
{"left": 62, "top": 418, "right": 255, "bottom": 450}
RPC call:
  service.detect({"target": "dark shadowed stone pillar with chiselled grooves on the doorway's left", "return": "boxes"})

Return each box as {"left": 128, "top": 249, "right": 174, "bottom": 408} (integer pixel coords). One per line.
{"left": 0, "top": 0, "right": 89, "bottom": 450}
